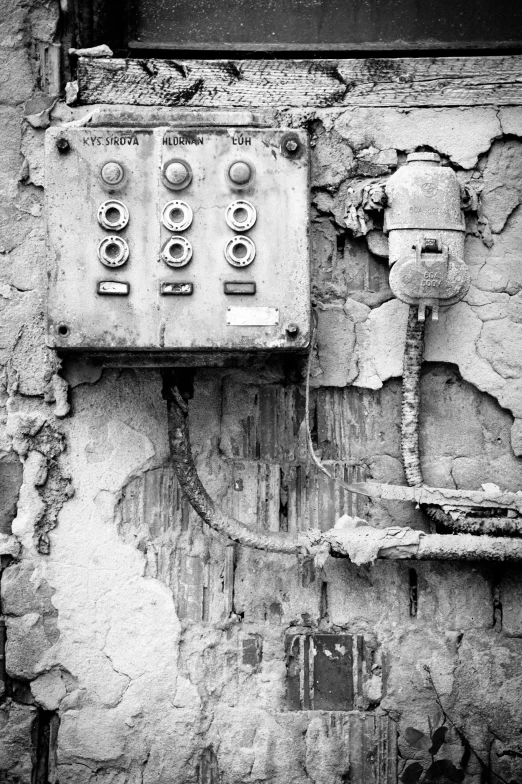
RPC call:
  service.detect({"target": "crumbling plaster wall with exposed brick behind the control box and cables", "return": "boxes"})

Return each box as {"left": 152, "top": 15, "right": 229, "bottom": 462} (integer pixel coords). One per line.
{"left": 0, "top": 0, "right": 522, "bottom": 784}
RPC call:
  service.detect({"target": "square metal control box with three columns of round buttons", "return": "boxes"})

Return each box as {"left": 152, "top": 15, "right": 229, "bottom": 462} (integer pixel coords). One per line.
{"left": 46, "top": 127, "right": 310, "bottom": 355}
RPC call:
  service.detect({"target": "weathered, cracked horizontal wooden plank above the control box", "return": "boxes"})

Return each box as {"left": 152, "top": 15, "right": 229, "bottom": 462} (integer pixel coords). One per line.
{"left": 78, "top": 55, "right": 522, "bottom": 109}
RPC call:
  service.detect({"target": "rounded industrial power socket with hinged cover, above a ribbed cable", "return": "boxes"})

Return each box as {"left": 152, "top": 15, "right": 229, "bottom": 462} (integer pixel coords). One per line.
{"left": 384, "top": 152, "right": 471, "bottom": 320}
